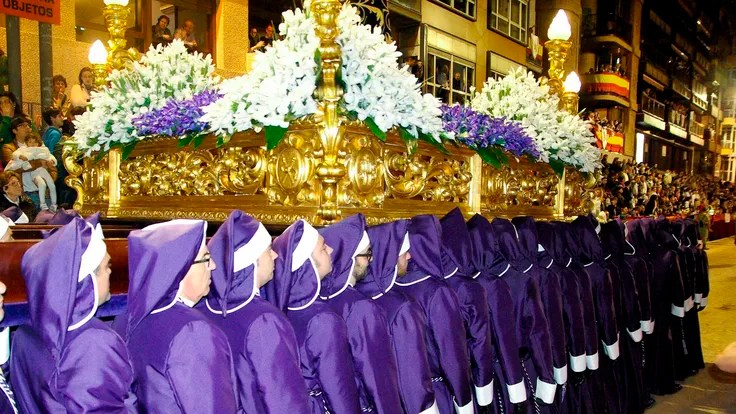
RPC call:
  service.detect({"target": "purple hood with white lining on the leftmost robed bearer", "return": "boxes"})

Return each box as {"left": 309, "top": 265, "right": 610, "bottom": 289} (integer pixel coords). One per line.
{"left": 21, "top": 218, "right": 107, "bottom": 361}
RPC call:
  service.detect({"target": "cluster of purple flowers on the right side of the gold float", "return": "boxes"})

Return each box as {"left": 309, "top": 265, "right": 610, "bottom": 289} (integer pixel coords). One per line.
{"left": 440, "top": 105, "right": 539, "bottom": 159}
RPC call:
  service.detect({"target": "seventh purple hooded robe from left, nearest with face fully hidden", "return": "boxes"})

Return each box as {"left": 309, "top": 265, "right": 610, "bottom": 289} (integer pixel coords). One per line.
{"left": 396, "top": 215, "right": 474, "bottom": 414}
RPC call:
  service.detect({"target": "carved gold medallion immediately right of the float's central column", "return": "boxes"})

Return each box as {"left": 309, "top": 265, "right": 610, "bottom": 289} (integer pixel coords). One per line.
{"left": 338, "top": 132, "right": 384, "bottom": 207}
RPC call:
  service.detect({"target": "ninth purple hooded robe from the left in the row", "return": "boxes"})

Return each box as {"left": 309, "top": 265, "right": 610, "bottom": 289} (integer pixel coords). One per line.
{"left": 467, "top": 214, "right": 527, "bottom": 413}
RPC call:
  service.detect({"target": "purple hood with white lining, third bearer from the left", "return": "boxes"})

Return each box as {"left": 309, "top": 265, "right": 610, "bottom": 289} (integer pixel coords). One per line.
{"left": 205, "top": 210, "right": 271, "bottom": 317}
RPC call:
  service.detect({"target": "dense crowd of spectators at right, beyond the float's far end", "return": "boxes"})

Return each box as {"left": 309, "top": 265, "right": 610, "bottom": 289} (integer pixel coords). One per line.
{"left": 592, "top": 155, "right": 736, "bottom": 246}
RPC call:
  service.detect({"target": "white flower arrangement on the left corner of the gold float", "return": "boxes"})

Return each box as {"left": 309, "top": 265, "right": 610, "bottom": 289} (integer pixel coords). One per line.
{"left": 74, "top": 40, "right": 219, "bottom": 156}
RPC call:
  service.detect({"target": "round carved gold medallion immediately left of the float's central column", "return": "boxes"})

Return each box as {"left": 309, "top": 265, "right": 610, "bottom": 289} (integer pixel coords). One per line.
{"left": 268, "top": 132, "right": 319, "bottom": 206}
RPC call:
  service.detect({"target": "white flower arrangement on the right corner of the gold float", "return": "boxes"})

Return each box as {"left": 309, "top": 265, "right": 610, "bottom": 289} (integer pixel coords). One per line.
{"left": 471, "top": 68, "right": 600, "bottom": 174}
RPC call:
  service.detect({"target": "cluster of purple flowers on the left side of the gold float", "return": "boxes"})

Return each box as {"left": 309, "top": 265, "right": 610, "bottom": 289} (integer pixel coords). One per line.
{"left": 133, "top": 90, "right": 220, "bottom": 137}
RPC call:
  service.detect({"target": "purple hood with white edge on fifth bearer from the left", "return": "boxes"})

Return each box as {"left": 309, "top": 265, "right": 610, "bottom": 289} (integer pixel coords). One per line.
{"left": 319, "top": 214, "right": 370, "bottom": 299}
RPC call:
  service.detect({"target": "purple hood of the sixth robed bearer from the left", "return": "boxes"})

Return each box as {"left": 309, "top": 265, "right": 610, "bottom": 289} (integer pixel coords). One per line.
{"left": 355, "top": 220, "right": 409, "bottom": 299}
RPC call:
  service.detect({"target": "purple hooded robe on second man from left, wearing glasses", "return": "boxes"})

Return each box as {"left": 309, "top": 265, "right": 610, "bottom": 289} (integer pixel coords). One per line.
{"left": 113, "top": 220, "right": 239, "bottom": 414}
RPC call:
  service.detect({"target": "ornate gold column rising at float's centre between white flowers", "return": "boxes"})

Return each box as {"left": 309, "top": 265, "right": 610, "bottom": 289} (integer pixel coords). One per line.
{"left": 311, "top": 0, "right": 346, "bottom": 224}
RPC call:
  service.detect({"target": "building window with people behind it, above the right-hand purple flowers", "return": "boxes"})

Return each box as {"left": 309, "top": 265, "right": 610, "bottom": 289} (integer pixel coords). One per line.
{"left": 427, "top": 50, "right": 475, "bottom": 104}
